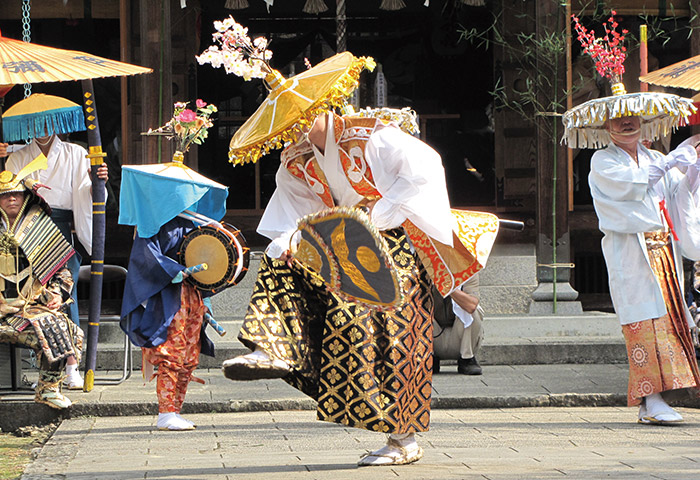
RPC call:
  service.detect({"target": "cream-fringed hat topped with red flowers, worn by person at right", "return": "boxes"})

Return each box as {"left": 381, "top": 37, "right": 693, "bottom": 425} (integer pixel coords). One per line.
{"left": 562, "top": 10, "right": 696, "bottom": 148}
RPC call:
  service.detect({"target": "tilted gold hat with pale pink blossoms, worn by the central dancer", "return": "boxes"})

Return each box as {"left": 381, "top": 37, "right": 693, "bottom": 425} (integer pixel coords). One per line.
{"left": 197, "top": 17, "right": 375, "bottom": 165}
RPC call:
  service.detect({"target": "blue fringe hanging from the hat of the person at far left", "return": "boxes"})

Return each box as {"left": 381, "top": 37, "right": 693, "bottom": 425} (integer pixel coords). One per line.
{"left": 2, "top": 106, "right": 85, "bottom": 142}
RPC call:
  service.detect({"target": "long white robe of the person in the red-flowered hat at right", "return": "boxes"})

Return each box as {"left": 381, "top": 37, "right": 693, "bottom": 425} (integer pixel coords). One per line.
{"left": 588, "top": 140, "right": 700, "bottom": 327}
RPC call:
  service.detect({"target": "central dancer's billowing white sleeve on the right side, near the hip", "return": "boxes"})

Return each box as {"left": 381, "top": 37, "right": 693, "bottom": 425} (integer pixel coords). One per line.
{"left": 366, "top": 127, "right": 455, "bottom": 246}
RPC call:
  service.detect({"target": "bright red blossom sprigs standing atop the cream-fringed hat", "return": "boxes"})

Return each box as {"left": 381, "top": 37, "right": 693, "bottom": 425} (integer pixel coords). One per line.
{"left": 571, "top": 10, "right": 628, "bottom": 85}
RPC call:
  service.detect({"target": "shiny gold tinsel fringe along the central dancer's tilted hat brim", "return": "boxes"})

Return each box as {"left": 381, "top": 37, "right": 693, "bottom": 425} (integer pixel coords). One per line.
{"left": 228, "top": 57, "right": 375, "bottom": 165}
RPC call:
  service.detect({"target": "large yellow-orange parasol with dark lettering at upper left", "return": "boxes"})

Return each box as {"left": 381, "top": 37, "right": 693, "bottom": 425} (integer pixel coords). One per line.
{"left": 0, "top": 33, "right": 152, "bottom": 85}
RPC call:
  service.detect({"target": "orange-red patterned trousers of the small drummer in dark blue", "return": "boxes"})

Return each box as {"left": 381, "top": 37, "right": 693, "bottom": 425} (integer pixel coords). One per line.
{"left": 142, "top": 282, "right": 206, "bottom": 413}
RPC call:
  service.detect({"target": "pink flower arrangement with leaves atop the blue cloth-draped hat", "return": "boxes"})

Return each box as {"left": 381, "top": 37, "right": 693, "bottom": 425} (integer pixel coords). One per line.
{"left": 146, "top": 99, "right": 217, "bottom": 153}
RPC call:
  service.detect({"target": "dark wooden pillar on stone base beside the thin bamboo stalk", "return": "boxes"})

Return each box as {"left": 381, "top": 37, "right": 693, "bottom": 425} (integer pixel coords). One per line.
{"left": 530, "top": 0, "right": 582, "bottom": 314}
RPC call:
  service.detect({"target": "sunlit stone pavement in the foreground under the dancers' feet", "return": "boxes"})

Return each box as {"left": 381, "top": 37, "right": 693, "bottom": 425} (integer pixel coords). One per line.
{"left": 22, "top": 407, "right": 700, "bottom": 480}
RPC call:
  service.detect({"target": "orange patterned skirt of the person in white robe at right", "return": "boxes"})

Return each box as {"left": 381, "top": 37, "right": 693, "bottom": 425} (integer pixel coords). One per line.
{"left": 622, "top": 232, "right": 700, "bottom": 406}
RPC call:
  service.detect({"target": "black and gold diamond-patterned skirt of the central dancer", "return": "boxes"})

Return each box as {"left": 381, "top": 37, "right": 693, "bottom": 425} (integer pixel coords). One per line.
{"left": 238, "top": 229, "right": 433, "bottom": 433}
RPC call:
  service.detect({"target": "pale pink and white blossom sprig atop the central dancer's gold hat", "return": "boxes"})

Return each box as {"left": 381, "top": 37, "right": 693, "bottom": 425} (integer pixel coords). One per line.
{"left": 196, "top": 16, "right": 272, "bottom": 81}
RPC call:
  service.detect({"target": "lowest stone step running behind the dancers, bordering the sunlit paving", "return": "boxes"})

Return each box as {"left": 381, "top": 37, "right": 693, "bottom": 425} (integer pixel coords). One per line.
{"left": 0, "top": 362, "right": 636, "bottom": 431}
